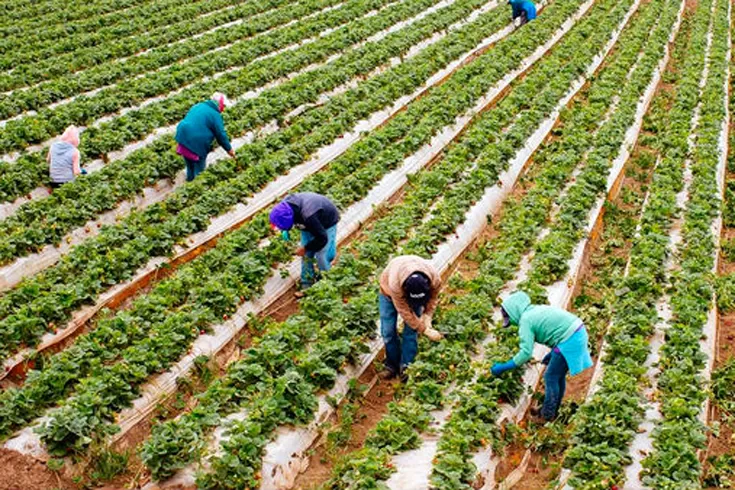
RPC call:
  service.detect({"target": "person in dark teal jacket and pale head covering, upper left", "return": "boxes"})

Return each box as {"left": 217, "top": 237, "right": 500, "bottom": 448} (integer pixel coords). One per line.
{"left": 176, "top": 92, "right": 235, "bottom": 182}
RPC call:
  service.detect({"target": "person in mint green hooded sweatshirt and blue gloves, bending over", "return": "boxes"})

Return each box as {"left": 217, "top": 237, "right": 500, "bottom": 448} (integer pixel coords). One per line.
{"left": 491, "top": 292, "right": 592, "bottom": 421}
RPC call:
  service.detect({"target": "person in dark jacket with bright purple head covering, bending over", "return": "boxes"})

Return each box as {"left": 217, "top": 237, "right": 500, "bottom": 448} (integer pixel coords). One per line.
{"left": 270, "top": 192, "right": 339, "bottom": 289}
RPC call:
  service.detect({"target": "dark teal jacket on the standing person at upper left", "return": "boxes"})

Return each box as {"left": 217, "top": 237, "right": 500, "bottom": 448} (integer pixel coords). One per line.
{"left": 176, "top": 100, "right": 232, "bottom": 159}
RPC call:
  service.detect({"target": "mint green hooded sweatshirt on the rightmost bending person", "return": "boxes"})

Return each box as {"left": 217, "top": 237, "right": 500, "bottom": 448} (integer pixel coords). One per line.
{"left": 503, "top": 292, "right": 582, "bottom": 366}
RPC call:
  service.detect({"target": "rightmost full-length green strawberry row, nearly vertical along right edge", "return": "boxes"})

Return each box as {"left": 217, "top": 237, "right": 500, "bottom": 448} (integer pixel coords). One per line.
{"left": 643, "top": 1, "right": 731, "bottom": 489}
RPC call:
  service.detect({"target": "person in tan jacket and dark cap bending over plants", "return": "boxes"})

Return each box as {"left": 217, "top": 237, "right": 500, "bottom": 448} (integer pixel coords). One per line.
{"left": 378, "top": 255, "right": 442, "bottom": 379}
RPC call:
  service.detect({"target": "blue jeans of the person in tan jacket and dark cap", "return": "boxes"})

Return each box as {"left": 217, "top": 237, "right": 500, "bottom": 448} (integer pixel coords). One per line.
{"left": 378, "top": 294, "right": 421, "bottom": 372}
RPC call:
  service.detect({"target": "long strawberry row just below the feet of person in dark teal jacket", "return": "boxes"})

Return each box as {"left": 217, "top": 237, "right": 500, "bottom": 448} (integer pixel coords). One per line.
{"left": 0, "top": 2, "right": 510, "bottom": 364}
